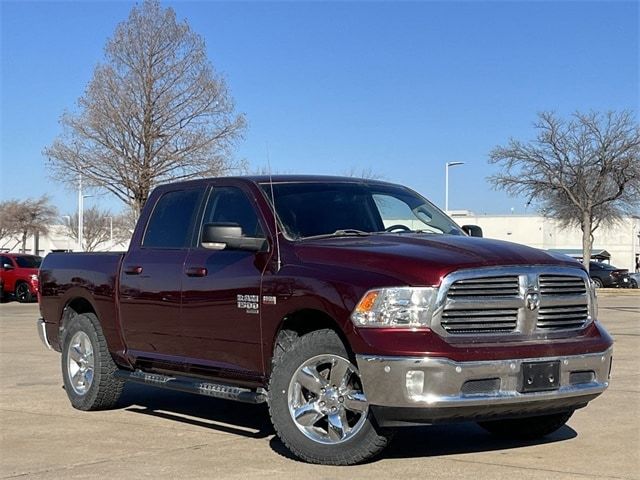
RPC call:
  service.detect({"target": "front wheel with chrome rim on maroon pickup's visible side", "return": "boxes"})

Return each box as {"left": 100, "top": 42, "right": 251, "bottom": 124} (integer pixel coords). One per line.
{"left": 268, "top": 330, "right": 390, "bottom": 465}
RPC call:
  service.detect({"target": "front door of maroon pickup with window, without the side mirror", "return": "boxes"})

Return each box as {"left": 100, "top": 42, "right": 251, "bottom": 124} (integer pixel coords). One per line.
{"left": 182, "top": 183, "right": 269, "bottom": 380}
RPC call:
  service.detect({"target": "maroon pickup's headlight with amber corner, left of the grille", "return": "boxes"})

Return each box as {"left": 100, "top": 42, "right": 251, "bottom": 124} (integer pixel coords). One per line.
{"left": 351, "top": 287, "right": 438, "bottom": 328}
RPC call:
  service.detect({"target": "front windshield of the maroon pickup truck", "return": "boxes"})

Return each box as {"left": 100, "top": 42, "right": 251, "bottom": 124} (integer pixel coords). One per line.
{"left": 261, "top": 182, "right": 464, "bottom": 239}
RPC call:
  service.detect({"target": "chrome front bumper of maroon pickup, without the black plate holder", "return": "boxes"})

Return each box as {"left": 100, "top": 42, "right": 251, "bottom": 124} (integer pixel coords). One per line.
{"left": 357, "top": 348, "right": 613, "bottom": 426}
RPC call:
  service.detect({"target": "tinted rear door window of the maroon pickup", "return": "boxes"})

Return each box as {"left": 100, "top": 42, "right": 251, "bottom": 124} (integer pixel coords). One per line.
{"left": 142, "top": 189, "right": 201, "bottom": 248}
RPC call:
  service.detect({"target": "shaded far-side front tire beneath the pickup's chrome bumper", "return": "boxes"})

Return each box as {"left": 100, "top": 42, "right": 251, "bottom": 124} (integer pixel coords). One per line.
{"left": 478, "top": 410, "right": 573, "bottom": 440}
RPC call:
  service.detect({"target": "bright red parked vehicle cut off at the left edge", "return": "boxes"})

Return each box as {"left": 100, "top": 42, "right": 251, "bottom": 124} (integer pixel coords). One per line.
{"left": 0, "top": 253, "right": 42, "bottom": 303}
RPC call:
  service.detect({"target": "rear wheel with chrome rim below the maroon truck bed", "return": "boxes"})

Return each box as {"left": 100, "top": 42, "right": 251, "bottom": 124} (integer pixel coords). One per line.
{"left": 62, "top": 313, "right": 124, "bottom": 410}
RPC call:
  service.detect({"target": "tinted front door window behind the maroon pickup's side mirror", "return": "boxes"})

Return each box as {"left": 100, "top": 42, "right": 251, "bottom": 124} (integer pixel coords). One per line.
{"left": 203, "top": 187, "right": 264, "bottom": 238}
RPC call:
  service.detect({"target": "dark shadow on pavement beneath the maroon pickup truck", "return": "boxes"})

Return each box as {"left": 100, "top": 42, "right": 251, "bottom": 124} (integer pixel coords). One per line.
{"left": 121, "top": 383, "right": 578, "bottom": 461}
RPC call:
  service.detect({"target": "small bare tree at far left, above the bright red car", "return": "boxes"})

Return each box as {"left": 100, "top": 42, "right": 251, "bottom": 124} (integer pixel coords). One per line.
{"left": 2, "top": 195, "right": 57, "bottom": 253}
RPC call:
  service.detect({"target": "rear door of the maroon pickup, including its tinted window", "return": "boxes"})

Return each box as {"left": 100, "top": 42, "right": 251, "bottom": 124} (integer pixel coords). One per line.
{"left": 119, "top": 187, "right": 204, "bottom": 364}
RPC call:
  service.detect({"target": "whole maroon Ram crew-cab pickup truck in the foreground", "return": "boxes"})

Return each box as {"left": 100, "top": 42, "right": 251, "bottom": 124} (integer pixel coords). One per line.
{"left": 38, "top": 176, "right": 612, "bottom": 465}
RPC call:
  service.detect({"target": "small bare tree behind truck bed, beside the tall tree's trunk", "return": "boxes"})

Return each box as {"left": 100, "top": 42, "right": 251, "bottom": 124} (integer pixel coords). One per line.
{"left": 62, "top": 207, "right": 132, "bottom": 252}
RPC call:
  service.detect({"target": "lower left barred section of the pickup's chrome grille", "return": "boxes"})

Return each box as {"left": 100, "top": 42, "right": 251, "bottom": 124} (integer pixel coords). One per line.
{"left": 440, "top": 308, "right": 518, "bottom": 333}
